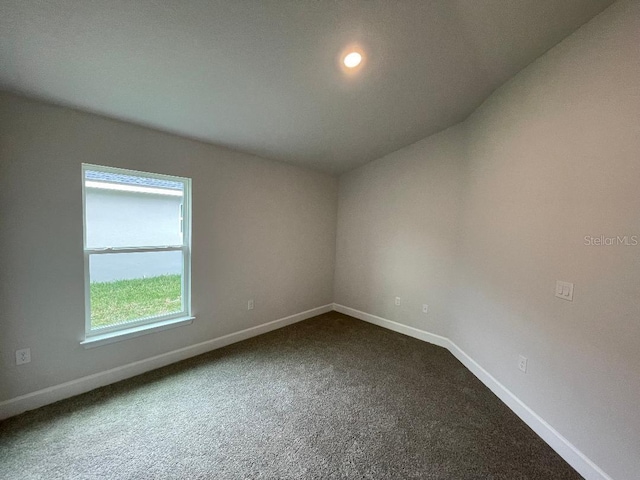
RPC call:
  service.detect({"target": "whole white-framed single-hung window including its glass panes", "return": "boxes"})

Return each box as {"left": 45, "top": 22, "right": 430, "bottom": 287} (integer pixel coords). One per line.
{"left": 82, "top": 164, "right": 192, "bottom": 343}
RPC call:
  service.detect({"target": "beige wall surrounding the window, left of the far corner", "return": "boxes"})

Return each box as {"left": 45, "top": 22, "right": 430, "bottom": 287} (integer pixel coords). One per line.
{"left": 0, "top": 94, "right": 337, "bottom": 400}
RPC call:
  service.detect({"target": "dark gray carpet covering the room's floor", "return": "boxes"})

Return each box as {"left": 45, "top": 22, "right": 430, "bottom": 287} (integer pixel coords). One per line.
{"left": 0, "top": 312, "right": 581, "bottom": 480}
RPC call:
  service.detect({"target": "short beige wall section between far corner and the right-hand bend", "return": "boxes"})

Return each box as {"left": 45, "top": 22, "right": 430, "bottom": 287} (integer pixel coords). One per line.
{"left": 334, "top": 127, "right": 464, "bottom": 336}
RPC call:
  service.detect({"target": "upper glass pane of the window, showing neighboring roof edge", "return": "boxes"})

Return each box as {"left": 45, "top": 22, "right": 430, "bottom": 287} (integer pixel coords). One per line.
{"left": 84, "top": 170, "right": 184, "bottom": 248}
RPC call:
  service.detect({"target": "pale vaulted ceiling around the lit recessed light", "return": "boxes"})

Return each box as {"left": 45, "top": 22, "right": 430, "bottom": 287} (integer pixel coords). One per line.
{"left": 0, "top": 0, "right": 613, "bottom": 173}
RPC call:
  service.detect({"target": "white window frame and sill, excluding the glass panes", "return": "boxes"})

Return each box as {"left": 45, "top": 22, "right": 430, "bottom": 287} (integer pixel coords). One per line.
{"left": 81, "top": 163, "right": 194, "bottom": 347}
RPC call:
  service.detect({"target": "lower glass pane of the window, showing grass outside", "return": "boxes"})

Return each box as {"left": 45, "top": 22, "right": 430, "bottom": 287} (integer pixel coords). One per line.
{"left": 89, "top": 251, "right": 184, "bottom": 329}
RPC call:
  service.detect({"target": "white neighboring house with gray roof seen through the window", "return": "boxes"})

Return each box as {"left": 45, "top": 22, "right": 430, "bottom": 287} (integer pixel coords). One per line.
{"left": 85, "top": 170, "right": 184, "bottom": 282}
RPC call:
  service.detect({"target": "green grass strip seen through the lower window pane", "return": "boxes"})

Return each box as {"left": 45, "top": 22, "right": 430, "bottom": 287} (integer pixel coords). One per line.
{"left": 90, "top": 275, "right": 182, "bottom": 328}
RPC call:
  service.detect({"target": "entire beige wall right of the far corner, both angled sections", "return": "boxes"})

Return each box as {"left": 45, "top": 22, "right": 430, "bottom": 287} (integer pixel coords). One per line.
{"left": 334, "top": 0, "right": 640, "bottom": 479}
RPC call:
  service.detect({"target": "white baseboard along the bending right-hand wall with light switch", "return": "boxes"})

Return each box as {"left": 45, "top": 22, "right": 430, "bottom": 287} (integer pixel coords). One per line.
{"left": 333, "top": 303, "right": 613, "bottom": 480}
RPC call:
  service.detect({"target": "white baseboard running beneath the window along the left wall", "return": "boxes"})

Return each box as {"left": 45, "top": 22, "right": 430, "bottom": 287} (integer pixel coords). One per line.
{"left": 0, "top": 304, "right": 333, "bottom": 420}
